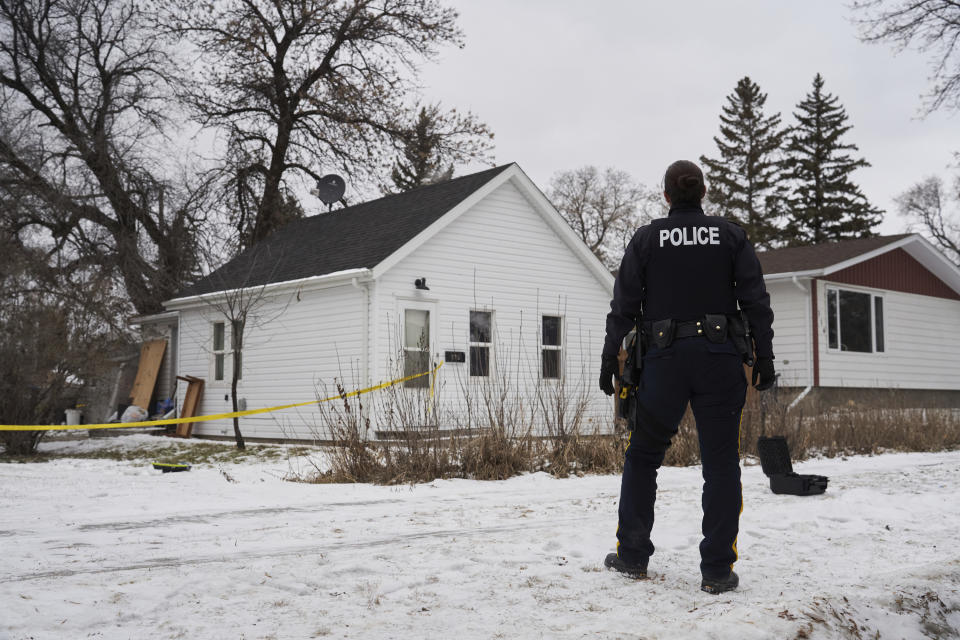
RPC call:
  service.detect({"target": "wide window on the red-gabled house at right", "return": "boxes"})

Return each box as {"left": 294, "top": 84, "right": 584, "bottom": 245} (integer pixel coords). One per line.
{"left": 827, "top": 289, "right": 884, "bottom": 353}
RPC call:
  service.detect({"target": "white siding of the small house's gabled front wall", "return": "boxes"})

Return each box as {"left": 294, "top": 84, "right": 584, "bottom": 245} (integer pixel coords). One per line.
{"left": 374, "top": 182, "right": 613, "bottom": 429}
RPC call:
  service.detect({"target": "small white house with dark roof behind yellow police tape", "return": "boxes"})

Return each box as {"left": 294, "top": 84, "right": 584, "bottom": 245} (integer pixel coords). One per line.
{"left": 151, "top": 164, "right": 613, "bottom": 439}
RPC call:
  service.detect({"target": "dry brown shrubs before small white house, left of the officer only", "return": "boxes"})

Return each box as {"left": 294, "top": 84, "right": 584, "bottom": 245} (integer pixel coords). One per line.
{"left": 304, "top": 344, "right": 625, "bottom": 484}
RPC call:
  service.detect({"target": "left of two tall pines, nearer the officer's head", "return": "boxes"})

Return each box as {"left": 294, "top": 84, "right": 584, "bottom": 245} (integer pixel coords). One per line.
{"left": 700, "top": 77, "right": 786, "bottom": 248}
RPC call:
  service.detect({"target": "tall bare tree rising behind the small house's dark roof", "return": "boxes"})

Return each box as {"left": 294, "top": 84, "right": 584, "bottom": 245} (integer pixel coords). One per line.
{"left": 166, "top": 0, "right": 490, "bottom": 246}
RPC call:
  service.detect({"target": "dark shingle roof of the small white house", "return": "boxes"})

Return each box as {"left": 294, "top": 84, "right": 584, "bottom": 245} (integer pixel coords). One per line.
{"left": 176, "top": 165, "right": 511, "bottom": 298}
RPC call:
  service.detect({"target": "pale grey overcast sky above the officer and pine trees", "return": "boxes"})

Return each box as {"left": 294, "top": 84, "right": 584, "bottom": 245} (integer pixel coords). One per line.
{"left": 422, "top": 0, "right": 960, "bottom": 234}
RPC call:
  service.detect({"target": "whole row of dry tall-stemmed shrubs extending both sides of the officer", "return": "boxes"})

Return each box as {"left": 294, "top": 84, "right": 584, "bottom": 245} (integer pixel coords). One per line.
{"left": 303, "top": 350, "right": 960, "bottom": 484}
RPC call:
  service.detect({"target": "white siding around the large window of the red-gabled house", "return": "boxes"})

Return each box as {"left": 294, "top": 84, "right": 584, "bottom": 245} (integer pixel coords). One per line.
{"left": 817, "top": 281, "right": 960, "bottom": 389}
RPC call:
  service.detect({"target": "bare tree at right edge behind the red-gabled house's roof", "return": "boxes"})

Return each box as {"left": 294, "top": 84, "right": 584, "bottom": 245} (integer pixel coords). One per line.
{"left": 896, "top": 173, "right": 960, "bottom": 267}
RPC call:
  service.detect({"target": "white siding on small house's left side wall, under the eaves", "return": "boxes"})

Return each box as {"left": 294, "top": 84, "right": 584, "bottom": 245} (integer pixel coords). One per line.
{"left": 178, "top": 284, "right": 366, "bottom": 439}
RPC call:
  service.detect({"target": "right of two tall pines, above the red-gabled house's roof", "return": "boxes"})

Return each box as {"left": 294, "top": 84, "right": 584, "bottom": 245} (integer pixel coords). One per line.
{"left": 786, "top": 73, "right": 883, "bottom": 246}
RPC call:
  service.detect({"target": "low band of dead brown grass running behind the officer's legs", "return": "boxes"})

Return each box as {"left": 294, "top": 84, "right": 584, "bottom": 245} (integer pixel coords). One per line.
{"left": 296, "top": 378, "right": 960, "bottom": 484}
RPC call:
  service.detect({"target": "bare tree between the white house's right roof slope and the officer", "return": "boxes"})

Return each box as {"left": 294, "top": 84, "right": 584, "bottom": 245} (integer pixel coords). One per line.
{"left": 548, "top": 166, "right": 661, "bottom": 270}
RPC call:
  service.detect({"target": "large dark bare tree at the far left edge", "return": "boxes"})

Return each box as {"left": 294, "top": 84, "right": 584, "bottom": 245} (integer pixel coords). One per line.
{"left": 0, "top": 0, "right": 204, "bottom": 313}
